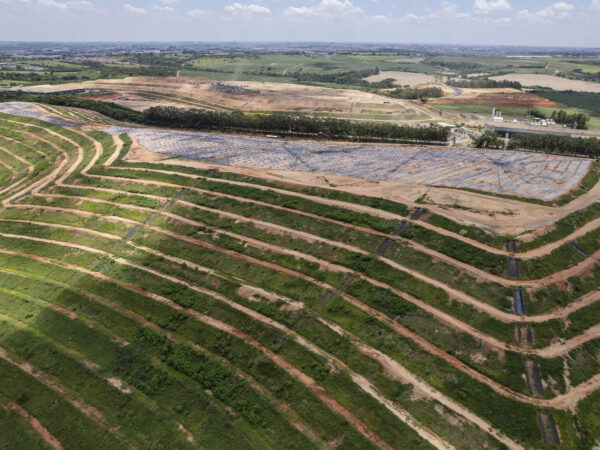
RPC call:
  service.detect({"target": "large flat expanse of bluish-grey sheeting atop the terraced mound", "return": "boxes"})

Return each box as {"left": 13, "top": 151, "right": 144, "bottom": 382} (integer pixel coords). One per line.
{"left": 105, "top": 127, "right": 591, "bottom": 200}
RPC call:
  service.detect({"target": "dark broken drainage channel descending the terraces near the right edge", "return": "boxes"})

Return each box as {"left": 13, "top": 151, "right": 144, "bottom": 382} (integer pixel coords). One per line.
{"left": 506, "top": 240, "right": 560, "bottom": 445}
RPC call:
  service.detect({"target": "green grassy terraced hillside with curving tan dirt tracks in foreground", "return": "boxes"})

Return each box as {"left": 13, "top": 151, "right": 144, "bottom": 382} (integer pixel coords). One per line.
{"left": 0, "top": 103, "right": 600, "bottom": 449}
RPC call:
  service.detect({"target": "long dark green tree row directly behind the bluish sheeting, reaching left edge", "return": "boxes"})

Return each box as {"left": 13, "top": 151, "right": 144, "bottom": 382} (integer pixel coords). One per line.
{"left": 0, "top": 92, "right": 450, "bottom": 142}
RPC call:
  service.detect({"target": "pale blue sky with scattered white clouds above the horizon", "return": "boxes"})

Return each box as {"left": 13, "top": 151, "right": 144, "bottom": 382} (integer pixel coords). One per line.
{"left": 0, "top": 0, "right": 600, "bottom": 47}
